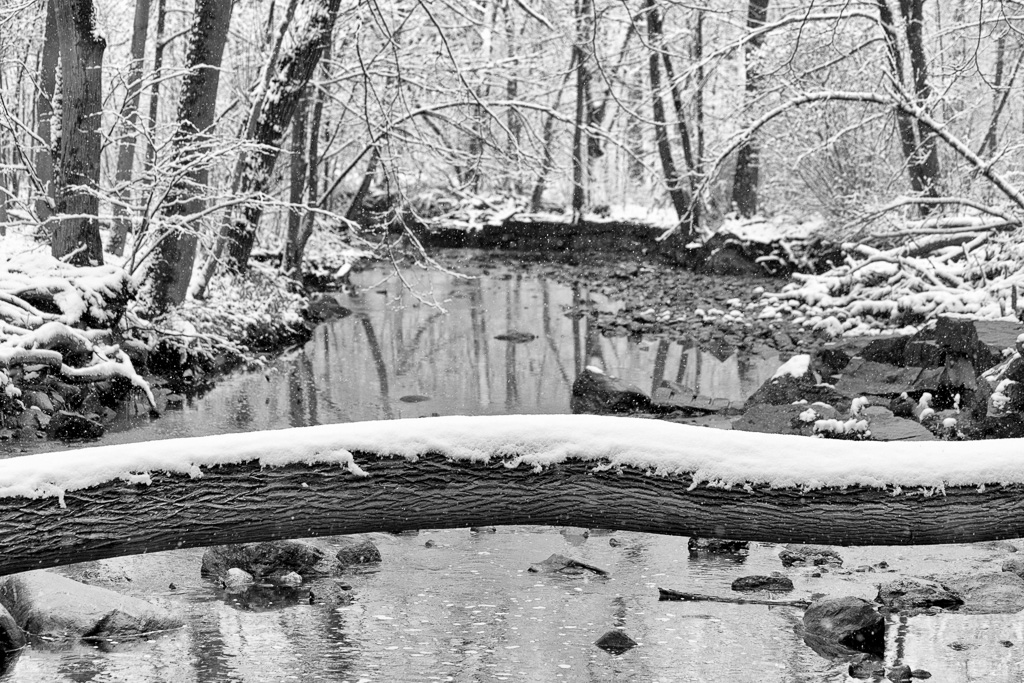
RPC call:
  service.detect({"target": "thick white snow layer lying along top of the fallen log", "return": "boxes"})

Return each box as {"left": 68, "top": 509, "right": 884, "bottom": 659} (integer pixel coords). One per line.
{"left": 0, "top": 415, "right": 1024, "bottom": 503}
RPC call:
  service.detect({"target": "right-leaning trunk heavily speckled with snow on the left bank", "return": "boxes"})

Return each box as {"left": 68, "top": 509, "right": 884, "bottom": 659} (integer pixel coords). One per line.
{"left": 224, "top": 0, "right": 340, "bottom": 271}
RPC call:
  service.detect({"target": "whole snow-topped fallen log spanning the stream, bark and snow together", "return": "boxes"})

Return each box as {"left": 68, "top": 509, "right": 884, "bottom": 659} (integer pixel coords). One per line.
{"left": 0, "top": 415, "right": 1024, "bottom": 573}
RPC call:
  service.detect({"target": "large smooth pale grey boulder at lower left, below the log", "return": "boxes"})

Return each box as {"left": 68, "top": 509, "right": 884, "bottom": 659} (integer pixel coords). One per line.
{"left": 0, "top": 571, "right": 183, "bottom": 640}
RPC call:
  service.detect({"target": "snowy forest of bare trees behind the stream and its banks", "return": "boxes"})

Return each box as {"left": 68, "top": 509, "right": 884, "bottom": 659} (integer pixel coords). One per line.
{"left": 0, "top": 0, "right": 1024, "bottom": 314}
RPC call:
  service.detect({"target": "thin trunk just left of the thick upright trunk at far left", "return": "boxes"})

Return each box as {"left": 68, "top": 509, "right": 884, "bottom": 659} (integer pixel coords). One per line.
{"left": 35, "top": 0, "right": 60, "bottom": 222}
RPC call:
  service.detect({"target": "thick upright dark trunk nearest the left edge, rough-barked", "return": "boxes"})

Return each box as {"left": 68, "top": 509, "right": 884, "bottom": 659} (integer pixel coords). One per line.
{"left": 50, "top": 0, "right": 106, "bottom": 265}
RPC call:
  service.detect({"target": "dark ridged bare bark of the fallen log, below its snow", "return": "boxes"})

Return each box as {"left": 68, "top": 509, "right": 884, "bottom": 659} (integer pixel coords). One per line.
{"left": 0, "top": 453, "right": 1024, "bottom": 574}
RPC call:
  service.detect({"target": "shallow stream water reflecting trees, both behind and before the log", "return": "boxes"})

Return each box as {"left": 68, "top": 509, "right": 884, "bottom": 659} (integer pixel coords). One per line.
{"left": 0, "top": 269, "right": 1024, "bottom": 683}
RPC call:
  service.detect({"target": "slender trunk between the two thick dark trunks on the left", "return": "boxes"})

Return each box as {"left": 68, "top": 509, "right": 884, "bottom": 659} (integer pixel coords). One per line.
{"left": 110, "top": 0, "right": 150, "bottom": 256}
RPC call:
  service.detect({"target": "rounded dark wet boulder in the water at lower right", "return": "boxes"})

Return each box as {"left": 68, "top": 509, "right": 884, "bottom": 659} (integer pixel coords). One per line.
{"left": 804, "top": 597, "right": 886, "bottom": 654}
